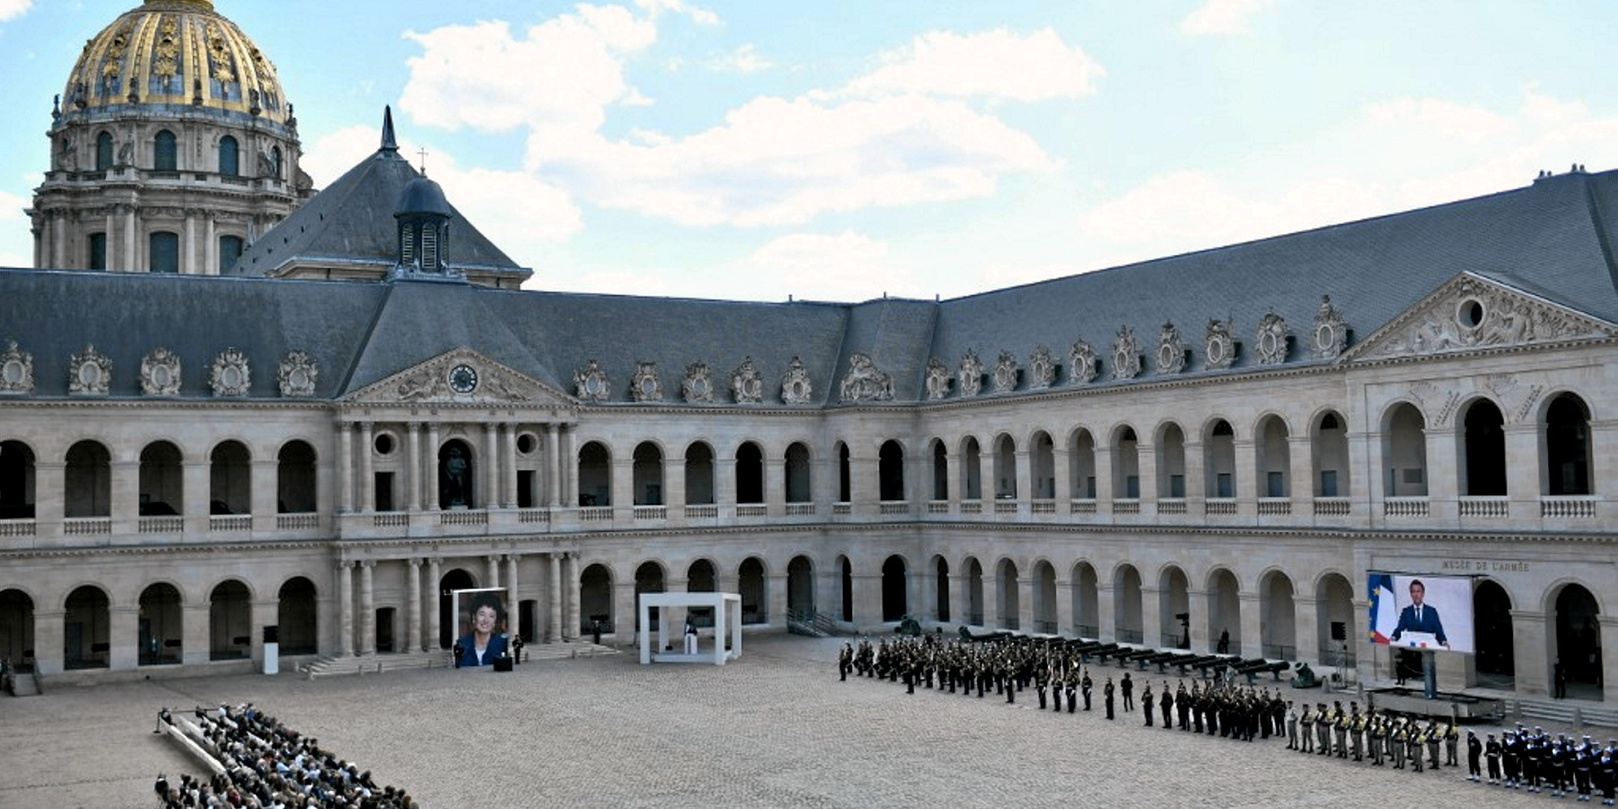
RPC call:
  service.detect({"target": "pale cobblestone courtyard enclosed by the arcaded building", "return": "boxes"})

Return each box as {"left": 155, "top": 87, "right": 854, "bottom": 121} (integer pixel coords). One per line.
{"left": 0, "top": 634, "right": 1573, "bottom": 809}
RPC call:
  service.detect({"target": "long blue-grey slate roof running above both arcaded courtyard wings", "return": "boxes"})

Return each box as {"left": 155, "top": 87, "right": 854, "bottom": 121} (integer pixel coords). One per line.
{"left": 0, "top": 168, "right": 1618, "bottom": 406}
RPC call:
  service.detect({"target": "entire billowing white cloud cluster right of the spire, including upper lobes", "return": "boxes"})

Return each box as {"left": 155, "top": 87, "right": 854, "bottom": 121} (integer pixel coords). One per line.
{"left": 400, "top": 11, "right": 1067, "bottom": 236}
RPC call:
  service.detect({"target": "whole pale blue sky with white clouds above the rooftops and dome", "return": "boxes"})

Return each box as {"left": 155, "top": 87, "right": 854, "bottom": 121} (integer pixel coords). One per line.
{"left": 0, "top": 0, "right": 1618, "bottom": 301}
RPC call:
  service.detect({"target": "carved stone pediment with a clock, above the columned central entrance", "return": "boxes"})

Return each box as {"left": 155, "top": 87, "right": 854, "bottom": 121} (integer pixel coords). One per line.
{"left": 343, "top": 348, "right": 576, "bottom": 408}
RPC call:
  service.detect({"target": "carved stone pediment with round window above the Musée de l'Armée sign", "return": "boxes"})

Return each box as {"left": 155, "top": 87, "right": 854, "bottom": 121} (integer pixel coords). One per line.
{"left": 1345, "top": 272, "right": 1618, "bottom": 362}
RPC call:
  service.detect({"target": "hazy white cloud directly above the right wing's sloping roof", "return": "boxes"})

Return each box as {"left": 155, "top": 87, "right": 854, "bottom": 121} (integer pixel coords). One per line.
{"left": 1078, "top": 87, "right": 1618, "bottom": 267}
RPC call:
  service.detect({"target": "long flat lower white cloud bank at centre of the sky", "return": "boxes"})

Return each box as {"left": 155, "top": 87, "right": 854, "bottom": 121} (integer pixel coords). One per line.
{"left": 531, "top": 95, "right": 1052, "bottom": 227}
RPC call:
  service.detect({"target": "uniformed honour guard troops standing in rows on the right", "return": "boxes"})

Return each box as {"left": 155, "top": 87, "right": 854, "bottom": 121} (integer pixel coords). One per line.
{"left": 838, "top": 631, "right": 1618, "bottom": 806}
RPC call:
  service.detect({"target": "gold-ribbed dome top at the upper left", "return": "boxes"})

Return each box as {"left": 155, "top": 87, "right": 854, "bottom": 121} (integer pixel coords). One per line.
{"left": 63, "top": 0, "right": 286, "bottom": 121}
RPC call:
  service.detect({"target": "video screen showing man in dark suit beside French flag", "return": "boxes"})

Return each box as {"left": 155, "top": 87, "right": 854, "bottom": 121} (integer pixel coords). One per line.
{"left": 1367, "top": 573, "right": 1474, "bottom": 654}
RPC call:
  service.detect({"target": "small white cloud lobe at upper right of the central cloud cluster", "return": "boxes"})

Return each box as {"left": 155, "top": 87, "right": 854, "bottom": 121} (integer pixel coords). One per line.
{"left": 848, "top": 28, "right": 1107, "bottom": 102}
